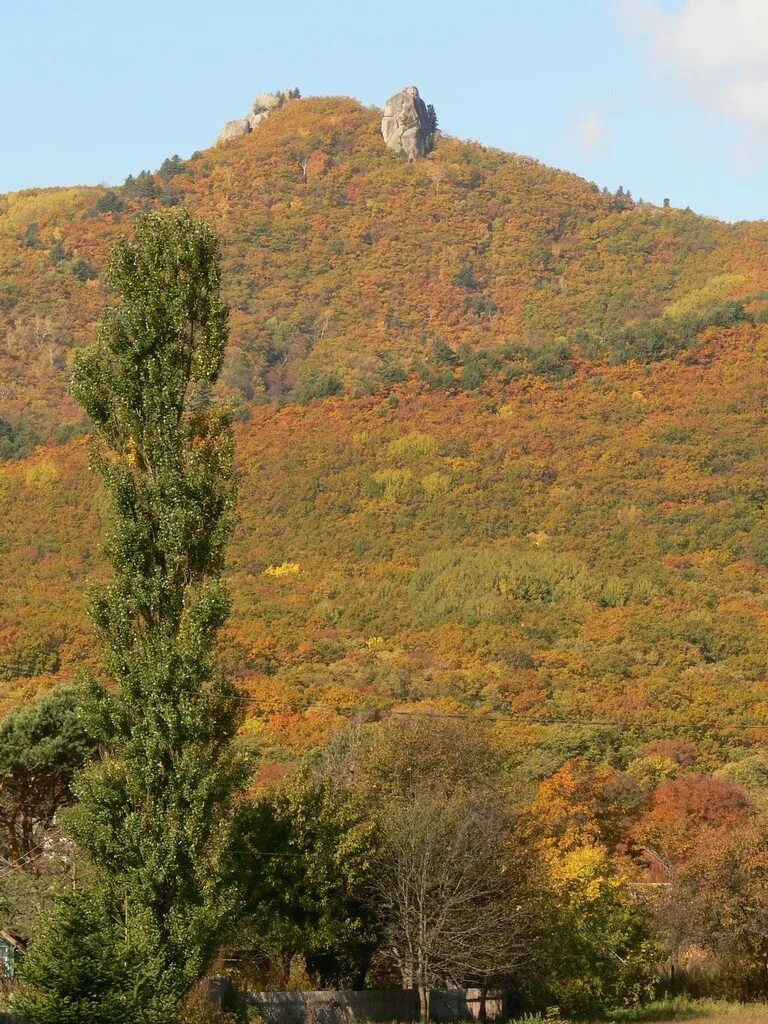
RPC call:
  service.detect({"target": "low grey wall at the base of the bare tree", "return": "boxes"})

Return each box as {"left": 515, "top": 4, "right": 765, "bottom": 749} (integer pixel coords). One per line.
{"left": 245, "top": 988, "right": 506, "bottom": 1024}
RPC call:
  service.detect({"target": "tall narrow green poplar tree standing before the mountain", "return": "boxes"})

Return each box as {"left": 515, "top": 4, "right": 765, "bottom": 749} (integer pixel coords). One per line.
{"left": 16, "top": 210, "right": 244, "bottom": 1024}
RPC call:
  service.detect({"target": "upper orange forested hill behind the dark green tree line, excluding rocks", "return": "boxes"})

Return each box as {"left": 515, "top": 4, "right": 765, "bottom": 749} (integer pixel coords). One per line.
{"left": 0, "top": 98, "right": 768, "bottom": 444}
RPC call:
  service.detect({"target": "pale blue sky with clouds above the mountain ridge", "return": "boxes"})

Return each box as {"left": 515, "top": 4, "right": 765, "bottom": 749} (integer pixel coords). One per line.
{"left": 0, "top": 0, "right": 768, "bottom": 220}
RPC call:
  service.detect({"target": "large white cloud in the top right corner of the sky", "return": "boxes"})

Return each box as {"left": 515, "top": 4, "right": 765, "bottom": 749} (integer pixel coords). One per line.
{"left": 618, "top": 0, "right": 768, "bottom": 129}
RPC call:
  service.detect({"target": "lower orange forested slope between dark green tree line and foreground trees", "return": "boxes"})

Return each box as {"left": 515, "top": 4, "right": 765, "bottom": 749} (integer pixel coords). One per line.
{"left": 0, "top": 327, "right": 768, "bottom": 767}
